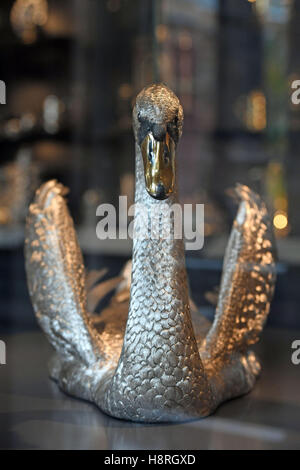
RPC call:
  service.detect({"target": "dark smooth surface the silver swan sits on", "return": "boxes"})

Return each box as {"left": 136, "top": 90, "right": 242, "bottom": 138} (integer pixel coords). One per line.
{"left": 0, "top": 328, "right": 300, "bottom": 450}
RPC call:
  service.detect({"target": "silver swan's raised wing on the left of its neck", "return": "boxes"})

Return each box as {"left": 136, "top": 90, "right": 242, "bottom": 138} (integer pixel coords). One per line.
{"left": 25, "top": 180, "right": 103, "bottom": 364}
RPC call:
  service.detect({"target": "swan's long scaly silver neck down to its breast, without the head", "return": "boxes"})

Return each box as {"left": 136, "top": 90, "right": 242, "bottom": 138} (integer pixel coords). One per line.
{"left": 103, "top": 141, "right": 209, "bottom": 421}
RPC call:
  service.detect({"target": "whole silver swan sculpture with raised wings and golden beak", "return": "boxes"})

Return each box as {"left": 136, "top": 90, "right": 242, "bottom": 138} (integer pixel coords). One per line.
{"left": 25, "top": 84, "right": 275, "bottom": 422}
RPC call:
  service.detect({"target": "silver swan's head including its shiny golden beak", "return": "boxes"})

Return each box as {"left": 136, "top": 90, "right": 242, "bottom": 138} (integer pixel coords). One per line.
{"left": 133, "top": 84, "right": 183, "bottom": 200}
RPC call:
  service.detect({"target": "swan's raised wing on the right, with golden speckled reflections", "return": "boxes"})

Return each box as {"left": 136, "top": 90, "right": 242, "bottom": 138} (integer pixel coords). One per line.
{"left": 201, "top": 185, "right": 276, "bottom": 359}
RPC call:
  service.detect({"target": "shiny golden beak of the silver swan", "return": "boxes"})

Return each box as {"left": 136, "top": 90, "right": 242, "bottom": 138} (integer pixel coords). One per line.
{"left": 141, "top": 133, "right": 175, "bottom": 200}
